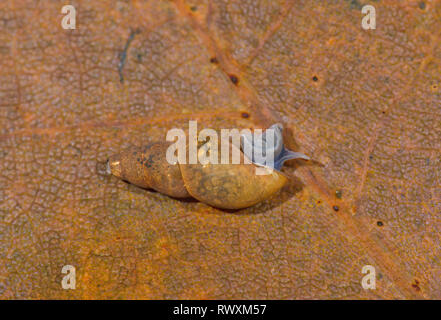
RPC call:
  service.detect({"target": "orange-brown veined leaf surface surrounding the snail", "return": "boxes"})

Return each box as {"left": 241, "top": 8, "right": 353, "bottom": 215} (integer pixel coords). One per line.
{"left": 0, "top": 0, "right": 441, "bottom": 299}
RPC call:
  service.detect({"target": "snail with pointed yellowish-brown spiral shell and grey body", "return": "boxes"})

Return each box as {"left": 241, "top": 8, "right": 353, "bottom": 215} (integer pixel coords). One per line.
{"left": 107, "top": 124, "right": 309, "bottom": 209}
